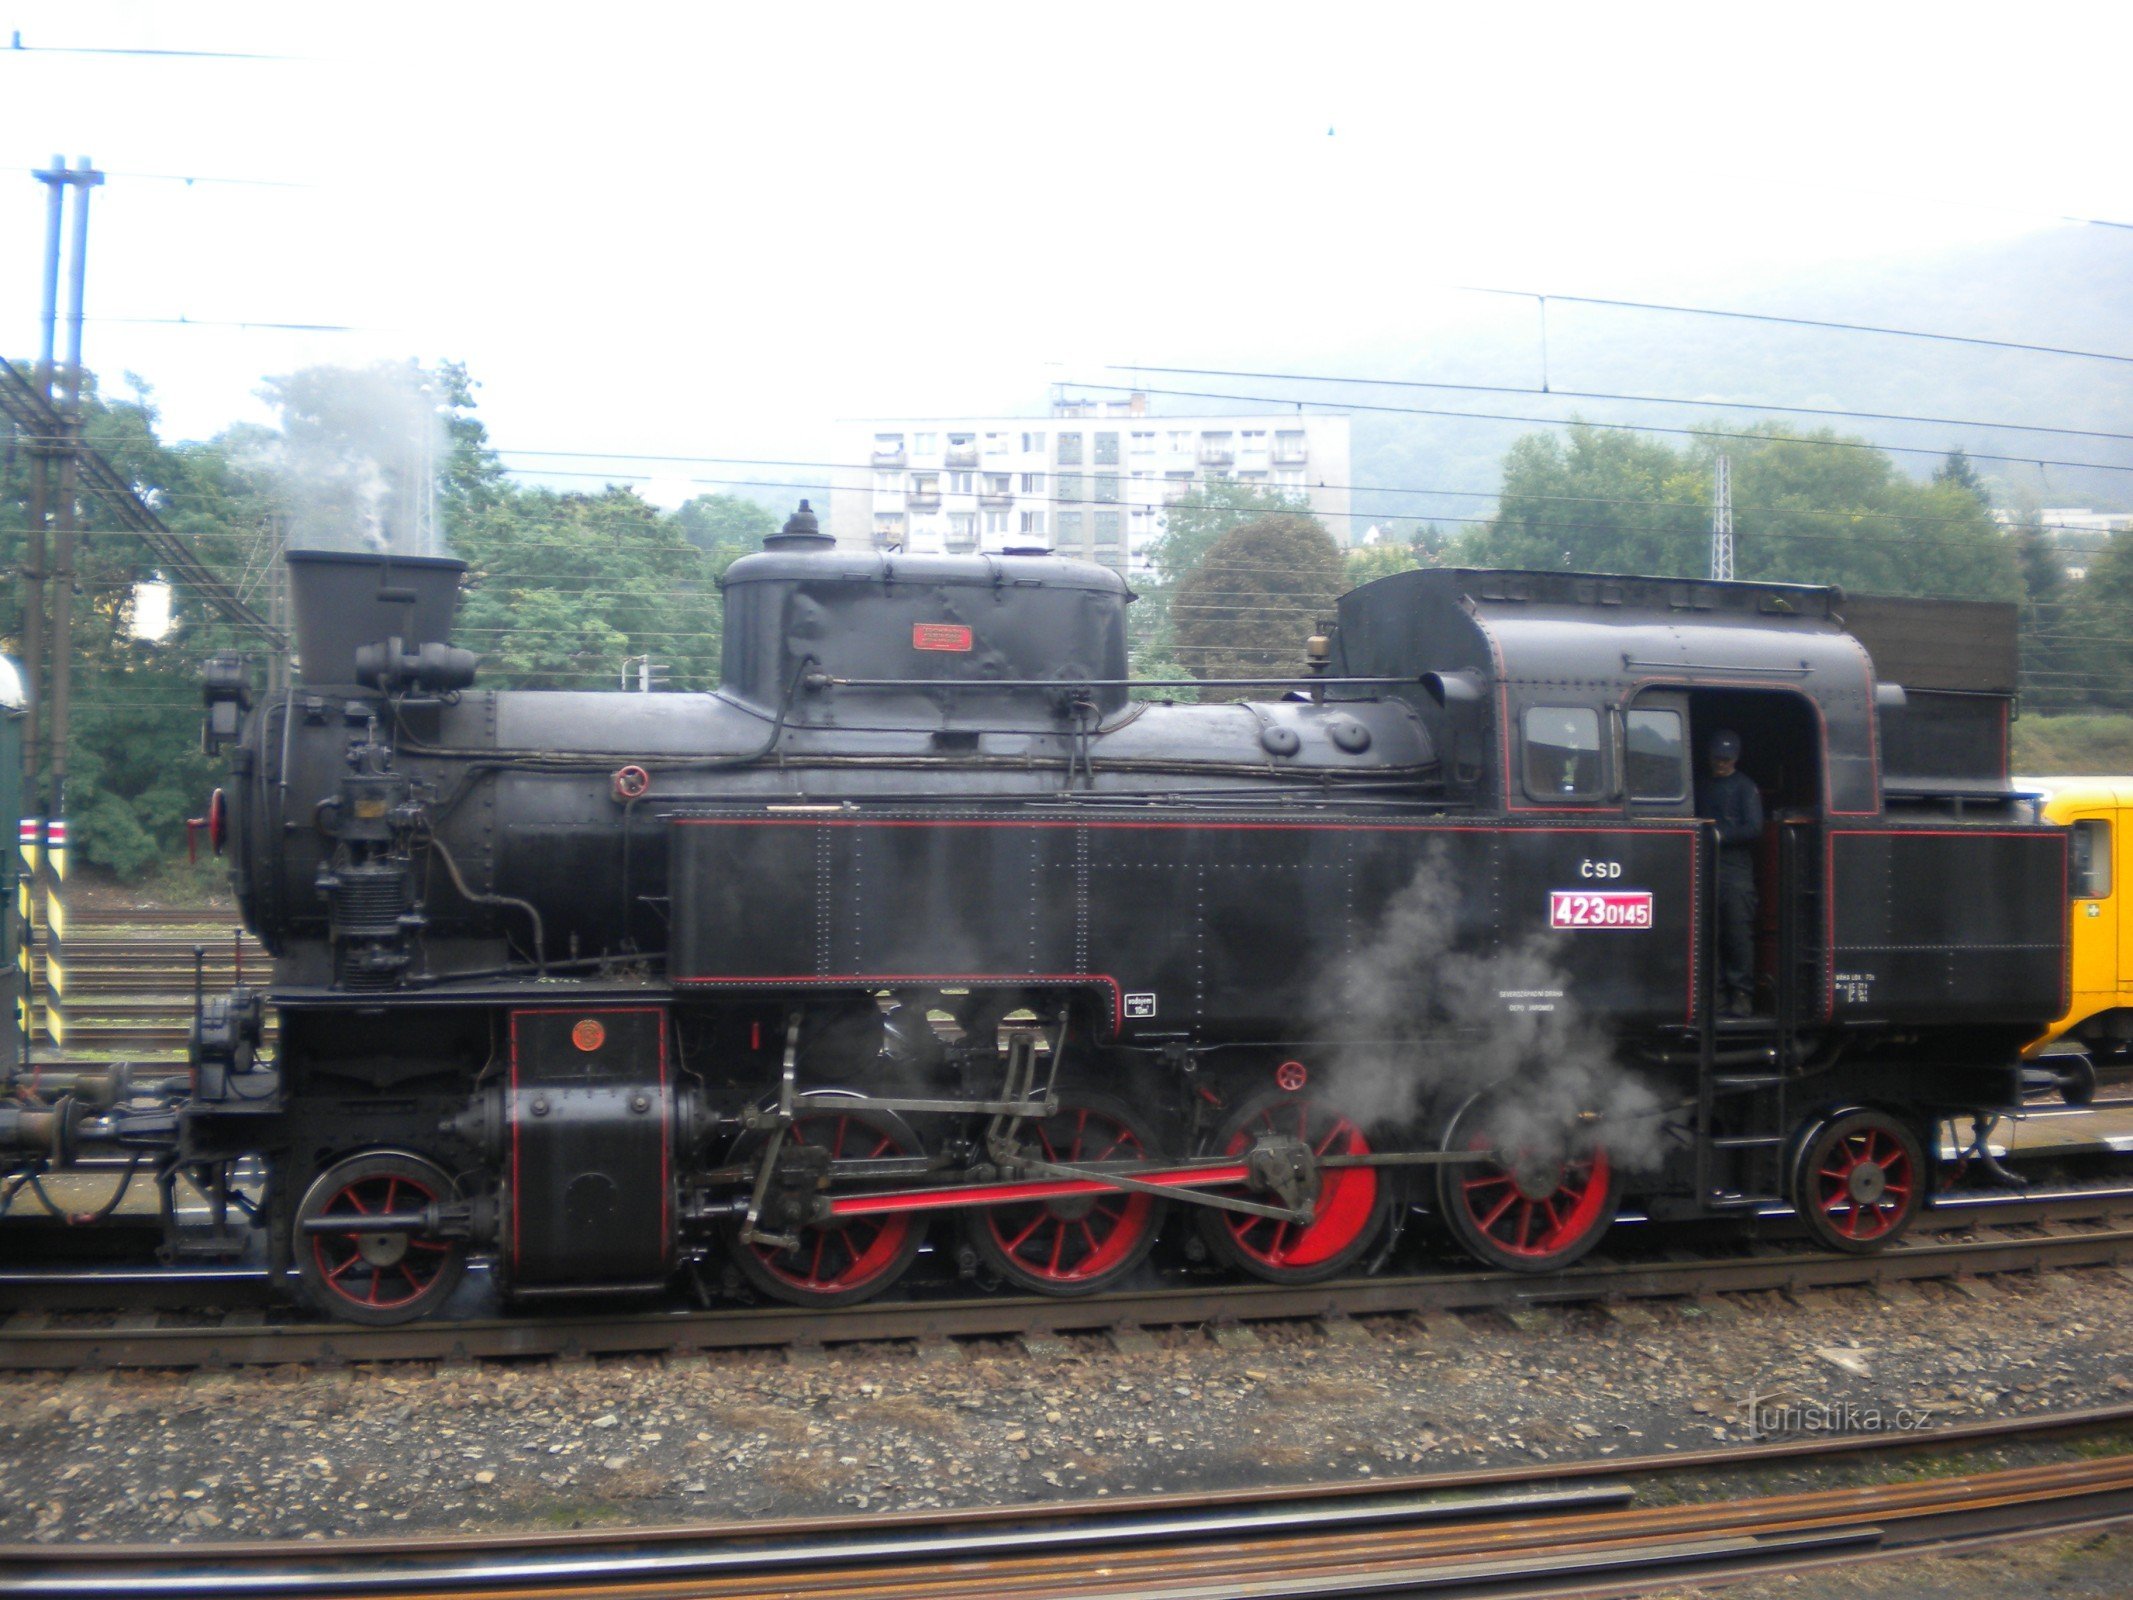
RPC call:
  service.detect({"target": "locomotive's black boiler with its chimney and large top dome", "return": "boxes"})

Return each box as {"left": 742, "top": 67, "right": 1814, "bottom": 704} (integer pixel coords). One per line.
{"left": 209, "top": 516, "right": 1436, "bottom": 990}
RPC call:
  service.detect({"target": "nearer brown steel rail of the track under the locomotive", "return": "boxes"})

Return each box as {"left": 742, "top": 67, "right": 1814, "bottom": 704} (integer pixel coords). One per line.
{"left": 0, "top": 1222, "right": 2133, "bottom": 1372}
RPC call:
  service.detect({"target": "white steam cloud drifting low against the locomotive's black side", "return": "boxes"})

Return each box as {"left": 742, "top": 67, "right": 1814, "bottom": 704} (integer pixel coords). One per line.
{"left": 1316, "top": 845, "right": 1662, "bottom": 1171}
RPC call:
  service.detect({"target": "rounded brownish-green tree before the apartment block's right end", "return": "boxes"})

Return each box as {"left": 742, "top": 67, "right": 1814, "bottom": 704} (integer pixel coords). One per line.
{"left": 1173, "top": 512, "right": 1346, "bottom": 681}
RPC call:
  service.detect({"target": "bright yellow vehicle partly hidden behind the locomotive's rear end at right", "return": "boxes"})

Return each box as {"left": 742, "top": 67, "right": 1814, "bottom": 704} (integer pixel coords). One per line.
{"left": 2014, "top": 777, "right": 2133, "bottom": 1101}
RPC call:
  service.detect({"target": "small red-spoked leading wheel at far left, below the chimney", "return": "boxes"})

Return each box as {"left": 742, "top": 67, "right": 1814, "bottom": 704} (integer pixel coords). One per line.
{"left": 294, "top": 1150, "right": 467, "bottom": 1325}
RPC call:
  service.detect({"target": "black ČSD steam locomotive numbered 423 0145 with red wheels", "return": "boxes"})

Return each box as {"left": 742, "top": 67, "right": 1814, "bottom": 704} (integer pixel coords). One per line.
{"left": 0, "top": 508, "right": 2067, "bottom": 1323}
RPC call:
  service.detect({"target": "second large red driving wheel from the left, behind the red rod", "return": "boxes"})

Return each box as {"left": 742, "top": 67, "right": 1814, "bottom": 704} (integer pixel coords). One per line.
{"left": 971, "top": 1092, "right": 1165, "bottom": 1295}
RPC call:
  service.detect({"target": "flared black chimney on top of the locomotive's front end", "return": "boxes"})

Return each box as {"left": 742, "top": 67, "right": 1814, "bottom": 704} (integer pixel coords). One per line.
{"left": 288, "top": 550, "right": 467, "bottom": 685}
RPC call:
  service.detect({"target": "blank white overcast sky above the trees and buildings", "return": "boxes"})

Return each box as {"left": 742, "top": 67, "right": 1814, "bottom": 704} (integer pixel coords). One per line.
{"left": 0, "top": 0, "right": 2133, "bottom": 493}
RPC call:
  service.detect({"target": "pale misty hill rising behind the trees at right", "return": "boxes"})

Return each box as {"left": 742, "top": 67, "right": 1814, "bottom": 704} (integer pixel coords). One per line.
{"left": 1237, "top": 224, "right": 2133, "bottom": 539}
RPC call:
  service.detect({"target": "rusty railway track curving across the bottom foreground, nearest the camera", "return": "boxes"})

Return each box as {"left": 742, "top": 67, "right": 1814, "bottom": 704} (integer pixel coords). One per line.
{"left": 0, "top": 1406, "right": 2133, "bottom": 1600}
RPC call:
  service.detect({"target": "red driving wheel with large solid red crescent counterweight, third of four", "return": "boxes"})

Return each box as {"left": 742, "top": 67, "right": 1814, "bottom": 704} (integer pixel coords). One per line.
{"left": 1201, "top": 1090, "right": 1393, "bottom": 1284}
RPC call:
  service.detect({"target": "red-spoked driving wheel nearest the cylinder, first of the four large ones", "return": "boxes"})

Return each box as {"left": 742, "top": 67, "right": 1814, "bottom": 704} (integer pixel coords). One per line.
{"left": 729, "top": 1094, "right": 926, "bottom": 1306}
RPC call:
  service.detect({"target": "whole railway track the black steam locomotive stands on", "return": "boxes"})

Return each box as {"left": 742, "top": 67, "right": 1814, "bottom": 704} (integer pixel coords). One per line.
{"left": 0, "top": 1190, "right": 2133, "bottom": 1372}
